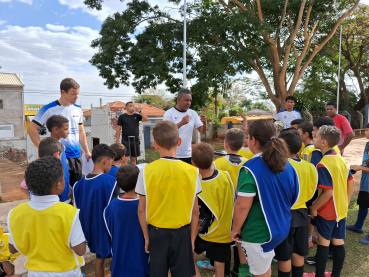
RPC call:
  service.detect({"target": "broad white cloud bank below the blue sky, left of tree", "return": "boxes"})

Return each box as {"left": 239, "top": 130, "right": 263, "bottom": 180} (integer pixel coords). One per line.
{"left": 0, "top": 25, "right": 134, "bottom": 108}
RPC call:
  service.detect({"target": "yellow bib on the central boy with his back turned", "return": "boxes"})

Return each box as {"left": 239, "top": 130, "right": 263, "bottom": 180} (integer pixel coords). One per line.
{"left": 144, "top": 158, "right": 199, "bottom": 229}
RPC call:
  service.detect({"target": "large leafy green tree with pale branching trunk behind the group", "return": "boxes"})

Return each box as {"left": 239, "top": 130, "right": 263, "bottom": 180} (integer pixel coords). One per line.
{"left": 84, "top": 0, "right": 360, "bottom": 110}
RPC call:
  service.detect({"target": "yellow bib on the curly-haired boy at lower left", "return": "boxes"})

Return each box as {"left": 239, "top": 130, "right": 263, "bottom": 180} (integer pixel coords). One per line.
{"left": 9, "top": 202, "right": 78, "bottom": 272}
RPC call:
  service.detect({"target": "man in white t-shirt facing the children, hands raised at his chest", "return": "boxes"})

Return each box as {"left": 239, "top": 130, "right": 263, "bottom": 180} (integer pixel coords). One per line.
{"left": 163, "top": 88, "right": 206, "bottom": 164}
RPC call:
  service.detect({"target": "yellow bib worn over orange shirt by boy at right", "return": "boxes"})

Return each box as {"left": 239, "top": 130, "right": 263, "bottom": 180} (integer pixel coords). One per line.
{"left": 320, "top": 152, "right": 348, "bottom": 221}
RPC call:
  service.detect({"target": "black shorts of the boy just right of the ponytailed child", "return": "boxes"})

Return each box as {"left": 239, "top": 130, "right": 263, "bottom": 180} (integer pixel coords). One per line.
{"left": 274, "top": 225, "right": 309, "bottom": 262}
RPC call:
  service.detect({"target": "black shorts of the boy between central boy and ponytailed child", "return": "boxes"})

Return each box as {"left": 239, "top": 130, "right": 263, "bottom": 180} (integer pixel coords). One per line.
{"left": 195, "top": 236, "right": 232, "bottom": 263}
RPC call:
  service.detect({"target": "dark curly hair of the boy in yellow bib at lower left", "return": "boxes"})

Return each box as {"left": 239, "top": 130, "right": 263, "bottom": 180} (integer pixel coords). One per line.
{"left": 24, "top": 156, "right": 64, "bottom": 196}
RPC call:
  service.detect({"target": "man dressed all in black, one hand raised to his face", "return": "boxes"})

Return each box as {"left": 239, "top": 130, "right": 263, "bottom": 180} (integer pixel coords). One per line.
{"left": 115, "top": 102, "right": 149, "bottom": 164}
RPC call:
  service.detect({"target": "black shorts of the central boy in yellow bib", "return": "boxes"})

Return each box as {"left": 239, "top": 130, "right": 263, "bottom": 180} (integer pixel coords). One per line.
{"left": 149, "top": 225, "right": 196, "bottom": 277}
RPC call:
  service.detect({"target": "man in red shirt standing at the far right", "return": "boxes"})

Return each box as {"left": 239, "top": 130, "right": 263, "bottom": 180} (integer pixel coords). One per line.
{"left": 326, "top": 102, "right": 354, "bottom": 154}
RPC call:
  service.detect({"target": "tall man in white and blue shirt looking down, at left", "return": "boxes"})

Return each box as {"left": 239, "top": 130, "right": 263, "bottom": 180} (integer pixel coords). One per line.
{"left": 27, "top": 78, "right": 91, "bottom": 186}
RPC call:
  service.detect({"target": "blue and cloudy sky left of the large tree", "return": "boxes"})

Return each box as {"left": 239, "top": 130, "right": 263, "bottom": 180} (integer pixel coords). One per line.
{"left": 0, "top": 0, "right": 369, "bottom": 109}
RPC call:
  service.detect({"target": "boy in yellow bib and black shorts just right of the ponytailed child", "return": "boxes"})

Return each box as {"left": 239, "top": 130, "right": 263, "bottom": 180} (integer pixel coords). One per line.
{"left": 274, "top": 128, "right": 318, "bottom": 277}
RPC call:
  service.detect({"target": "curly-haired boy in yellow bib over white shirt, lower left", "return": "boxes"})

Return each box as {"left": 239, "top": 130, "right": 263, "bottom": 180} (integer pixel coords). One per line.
{"left": 8, "top": 156, "right": 86, "bottom": 277}
